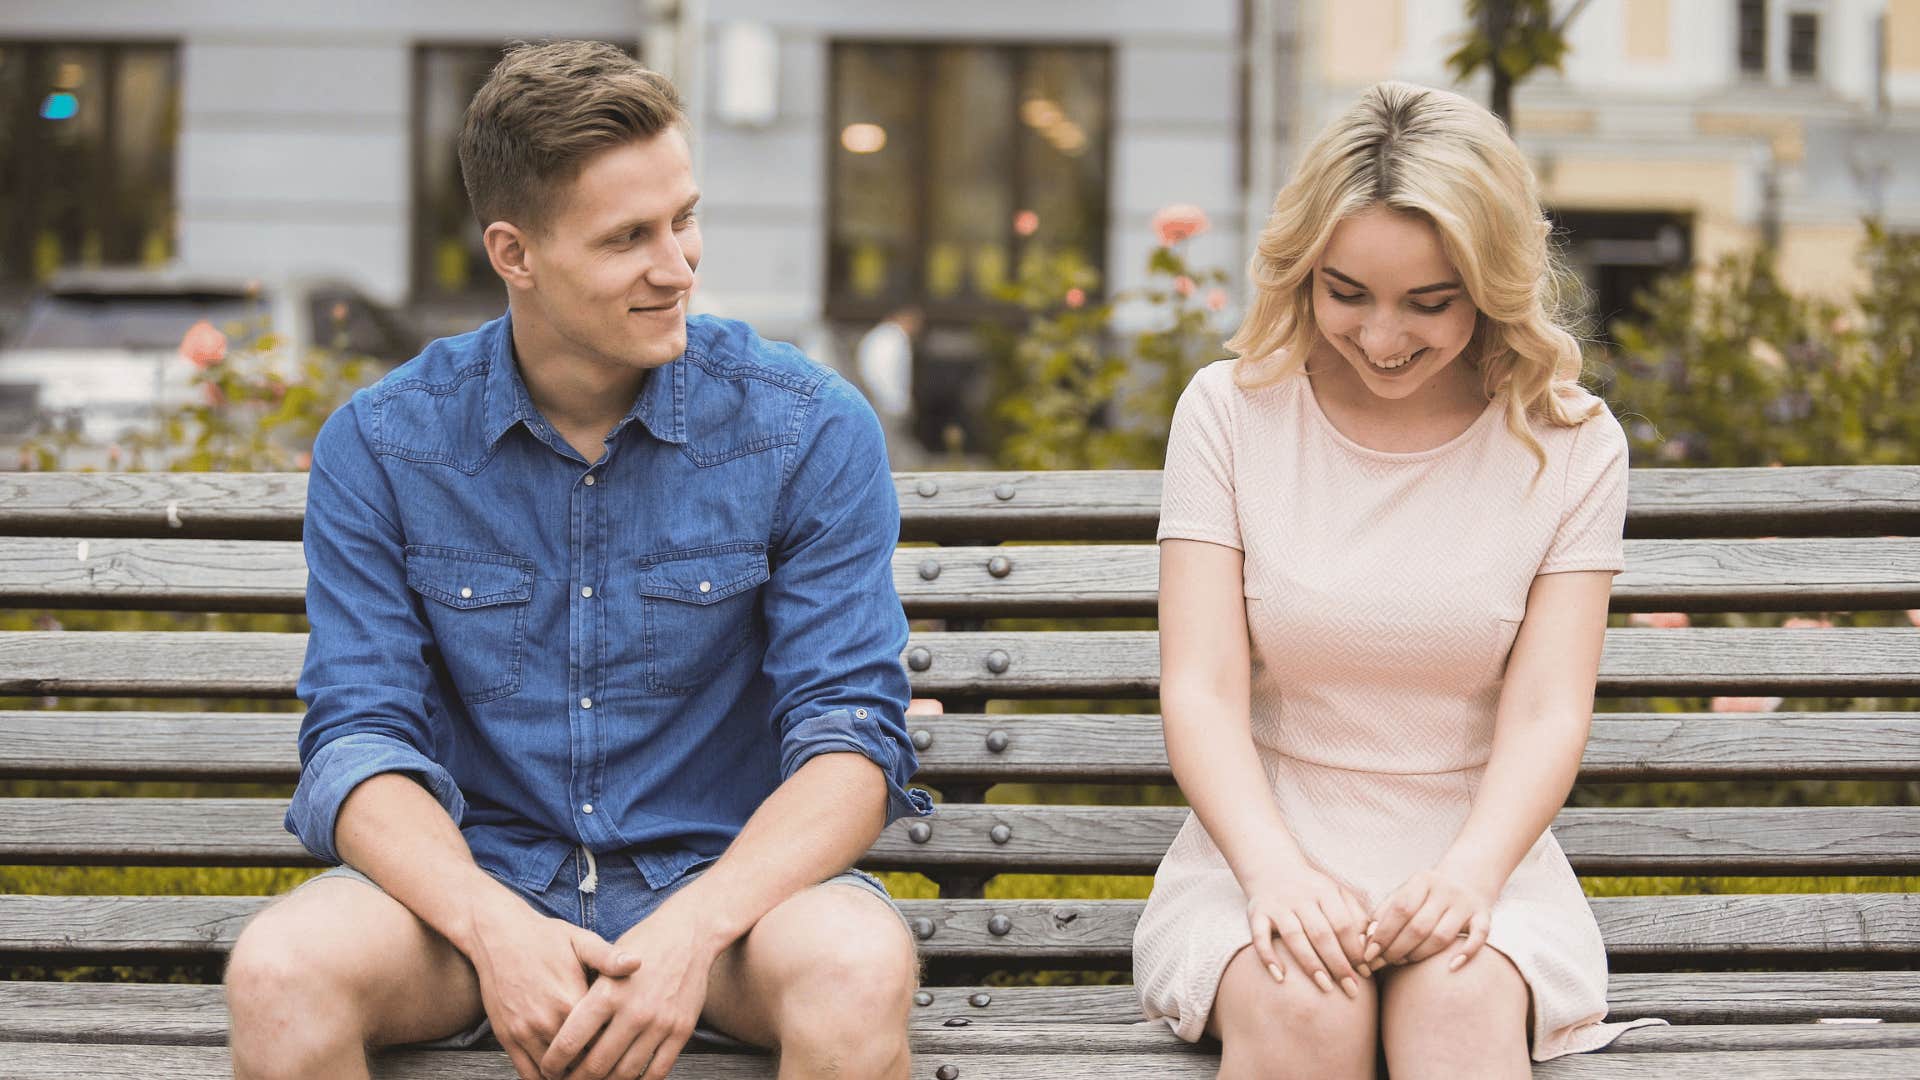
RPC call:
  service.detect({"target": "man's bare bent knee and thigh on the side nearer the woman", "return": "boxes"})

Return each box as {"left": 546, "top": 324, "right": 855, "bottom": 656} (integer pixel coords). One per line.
{"left": 703, "top": 884, "right": 918, "bottom": 1080}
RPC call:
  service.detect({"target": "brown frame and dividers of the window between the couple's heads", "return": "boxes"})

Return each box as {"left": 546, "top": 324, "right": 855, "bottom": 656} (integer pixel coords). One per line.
{"left": 820, "top": 37, "right": 1117, "bottom": 325}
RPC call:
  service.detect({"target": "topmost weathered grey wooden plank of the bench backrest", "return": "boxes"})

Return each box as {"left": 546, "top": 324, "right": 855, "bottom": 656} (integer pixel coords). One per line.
{"left": 11, "top": 465, "right": 1920, "bottom": 542}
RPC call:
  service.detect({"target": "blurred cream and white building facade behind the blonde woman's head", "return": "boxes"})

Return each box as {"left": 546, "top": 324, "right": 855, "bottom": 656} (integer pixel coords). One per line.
{"left": 1300, "top": 0, "right": 1920, "bottom": 319}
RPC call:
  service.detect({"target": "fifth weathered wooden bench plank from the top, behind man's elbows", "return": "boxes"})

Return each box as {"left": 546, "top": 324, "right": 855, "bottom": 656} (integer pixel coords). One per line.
{"left": 0, "top": 798, "right": 1920, "bottom": 874}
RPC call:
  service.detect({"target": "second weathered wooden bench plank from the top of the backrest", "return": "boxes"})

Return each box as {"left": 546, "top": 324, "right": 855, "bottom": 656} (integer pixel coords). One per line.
{"left": 15, "top": 536, "right": 1920, "bottom": 619}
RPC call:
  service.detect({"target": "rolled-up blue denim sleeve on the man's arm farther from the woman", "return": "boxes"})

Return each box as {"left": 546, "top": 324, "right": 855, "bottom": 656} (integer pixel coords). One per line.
{"left": 286, "top": 396, "right": 467, "bottom": 863}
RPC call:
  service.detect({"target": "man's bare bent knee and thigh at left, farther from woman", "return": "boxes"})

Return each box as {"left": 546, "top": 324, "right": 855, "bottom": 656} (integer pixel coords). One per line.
{"left": 227, "top": 878, "right": 484, "bottom": 1080}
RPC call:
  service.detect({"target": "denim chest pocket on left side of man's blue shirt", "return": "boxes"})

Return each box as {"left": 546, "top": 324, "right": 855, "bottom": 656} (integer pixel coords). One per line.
{"left": 405, "top": 544, "right": 534, "bottom": 705}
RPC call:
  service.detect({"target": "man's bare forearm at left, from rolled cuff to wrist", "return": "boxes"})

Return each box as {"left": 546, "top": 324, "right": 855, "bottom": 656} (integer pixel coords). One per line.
{"left": 334, "top": 773, "right": 520, "bottom": 955}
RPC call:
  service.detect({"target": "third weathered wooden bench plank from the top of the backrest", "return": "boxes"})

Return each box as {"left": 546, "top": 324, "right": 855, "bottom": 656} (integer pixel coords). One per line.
{"left": 0, "top": 628, "right": 1920, "bottom": 698}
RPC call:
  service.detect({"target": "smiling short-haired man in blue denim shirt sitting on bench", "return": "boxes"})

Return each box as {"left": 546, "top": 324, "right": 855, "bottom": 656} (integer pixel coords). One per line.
{"left": 227, "top": 42, "right": 931, "bottom": 1080}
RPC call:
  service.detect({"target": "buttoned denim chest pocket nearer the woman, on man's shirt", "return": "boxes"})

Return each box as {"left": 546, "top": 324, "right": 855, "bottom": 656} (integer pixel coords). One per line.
{"left": 634, "top": 544, "right": 768, "bottom": 694}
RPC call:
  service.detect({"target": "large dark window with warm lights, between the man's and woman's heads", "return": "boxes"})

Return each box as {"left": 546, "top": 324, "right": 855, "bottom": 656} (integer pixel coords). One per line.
{"left": 828, "top": 42, "right": 1112, "bottom": 321}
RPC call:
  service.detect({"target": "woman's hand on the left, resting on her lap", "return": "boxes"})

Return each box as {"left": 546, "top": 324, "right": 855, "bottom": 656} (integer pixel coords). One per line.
{"left": 1246, "top": 867, "right": 1371, "bottom": 997}
